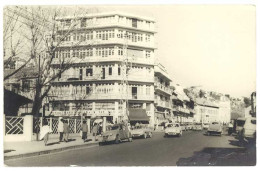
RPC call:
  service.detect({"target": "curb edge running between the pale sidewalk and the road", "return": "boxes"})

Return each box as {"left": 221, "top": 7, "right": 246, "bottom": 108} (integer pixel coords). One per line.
{"left": 4, "top": 142, "right": 99, "bottom": 160}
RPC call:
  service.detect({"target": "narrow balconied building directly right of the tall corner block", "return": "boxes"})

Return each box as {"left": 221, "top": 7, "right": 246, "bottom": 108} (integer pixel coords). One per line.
{"left": 154, "top": 64, "right": 172, "bottom": 125}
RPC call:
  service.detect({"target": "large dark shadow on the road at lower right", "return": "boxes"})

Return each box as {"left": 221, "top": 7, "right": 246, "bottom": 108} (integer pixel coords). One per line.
{"left": 176, "top": 148, "right": 256, "bottom": 166}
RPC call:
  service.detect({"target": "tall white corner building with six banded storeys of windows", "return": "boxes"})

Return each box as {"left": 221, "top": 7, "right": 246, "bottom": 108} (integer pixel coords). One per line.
{"left": 49, "top": 13, "right": 156, "bottom": 125}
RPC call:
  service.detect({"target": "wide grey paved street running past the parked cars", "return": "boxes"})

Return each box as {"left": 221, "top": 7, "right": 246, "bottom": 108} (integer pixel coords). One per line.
{"left": 5, "top": 131, "right": 256, "bottom": 166}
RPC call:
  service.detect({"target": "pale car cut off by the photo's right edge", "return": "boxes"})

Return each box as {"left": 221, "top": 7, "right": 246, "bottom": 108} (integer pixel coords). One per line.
{"left": 239, "top": 117, "right": 256, "bottom": 141}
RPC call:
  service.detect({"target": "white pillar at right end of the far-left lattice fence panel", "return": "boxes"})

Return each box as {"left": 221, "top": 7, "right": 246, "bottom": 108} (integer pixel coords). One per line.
{"left": 23, "top": 115, "right": 33, "bottom": 141}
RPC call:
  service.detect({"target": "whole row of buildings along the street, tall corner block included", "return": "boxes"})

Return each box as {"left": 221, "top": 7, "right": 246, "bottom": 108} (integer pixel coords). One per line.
{"left": 5, "top": 13, "right": 230, "bottom": 126}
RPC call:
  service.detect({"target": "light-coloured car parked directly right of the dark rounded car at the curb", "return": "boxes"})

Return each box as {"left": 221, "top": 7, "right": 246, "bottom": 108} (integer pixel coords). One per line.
{"left": 131, "top": 125, "right": 153, "bottom": 138}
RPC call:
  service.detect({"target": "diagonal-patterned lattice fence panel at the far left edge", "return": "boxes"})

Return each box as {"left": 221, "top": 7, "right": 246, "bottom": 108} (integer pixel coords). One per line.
{"left": 5, "top": 116, "right": 24, "bottom": 134}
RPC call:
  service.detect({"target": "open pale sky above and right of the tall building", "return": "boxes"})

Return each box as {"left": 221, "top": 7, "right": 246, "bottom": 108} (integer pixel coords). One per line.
{"left": 90, "top": 5, "right": 256, "bottom": 97}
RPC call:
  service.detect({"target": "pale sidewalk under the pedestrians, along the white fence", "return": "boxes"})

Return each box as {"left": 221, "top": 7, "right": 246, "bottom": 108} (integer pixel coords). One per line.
{"left": 4, "top": 134, "right": 101, "bottom": 160}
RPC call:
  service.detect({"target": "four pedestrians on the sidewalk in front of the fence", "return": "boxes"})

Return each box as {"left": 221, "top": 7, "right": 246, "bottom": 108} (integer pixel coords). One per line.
{"left": 40, "top": 118, "right": 89, "bottom": 146}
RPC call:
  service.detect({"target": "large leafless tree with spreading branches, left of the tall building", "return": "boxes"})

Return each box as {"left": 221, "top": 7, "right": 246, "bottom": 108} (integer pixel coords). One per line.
{"left": 4, "top": 6, "right": 93, "bottom": 115}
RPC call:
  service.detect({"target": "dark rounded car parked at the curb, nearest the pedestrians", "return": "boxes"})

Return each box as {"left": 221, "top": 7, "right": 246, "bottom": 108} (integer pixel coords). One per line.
{"left": 100, "top": 124, "right": 132, "bottom": 144}
